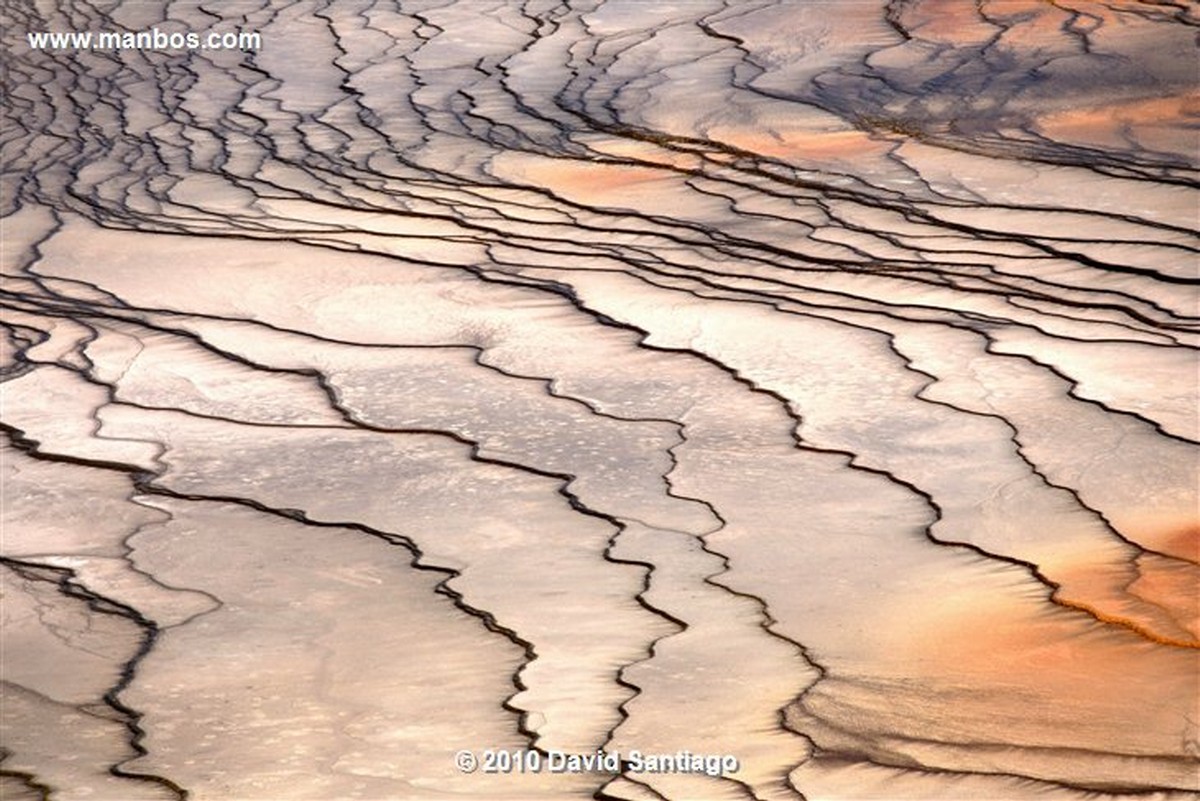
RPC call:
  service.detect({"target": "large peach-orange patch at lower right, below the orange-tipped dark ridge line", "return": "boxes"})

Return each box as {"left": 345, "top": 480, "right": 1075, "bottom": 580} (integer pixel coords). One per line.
{"left": 905, "top": 582, "right": 1200, "bottom": 754}
